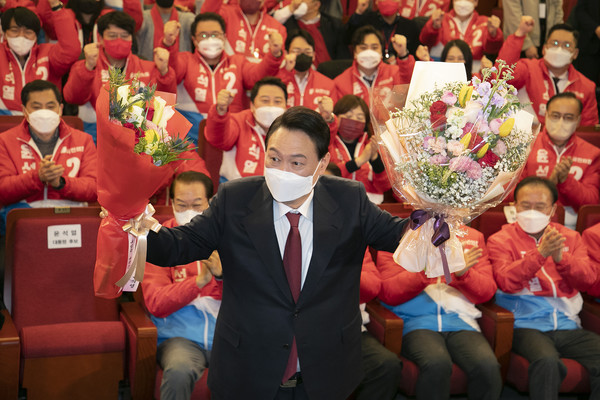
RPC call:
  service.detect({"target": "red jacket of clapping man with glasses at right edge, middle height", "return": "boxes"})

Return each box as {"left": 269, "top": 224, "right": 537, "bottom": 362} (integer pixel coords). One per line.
{"left": 521, "top": 128, "right": 600, "bottom": 211}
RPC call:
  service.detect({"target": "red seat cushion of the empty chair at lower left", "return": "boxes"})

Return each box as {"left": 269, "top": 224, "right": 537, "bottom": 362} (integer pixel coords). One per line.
{"left": 21, "top": 321, "right": 125, "bottom": 358}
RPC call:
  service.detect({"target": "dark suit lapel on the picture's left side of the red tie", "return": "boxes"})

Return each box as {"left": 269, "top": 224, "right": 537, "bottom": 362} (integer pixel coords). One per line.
{"left": 242, "top": 184, "right": 294, "bottom": 303}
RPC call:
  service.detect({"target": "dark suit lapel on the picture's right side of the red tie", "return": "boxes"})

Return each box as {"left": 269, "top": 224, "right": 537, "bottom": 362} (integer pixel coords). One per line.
{"left": 298, "top": 182, "right": 343, "bottom": 302}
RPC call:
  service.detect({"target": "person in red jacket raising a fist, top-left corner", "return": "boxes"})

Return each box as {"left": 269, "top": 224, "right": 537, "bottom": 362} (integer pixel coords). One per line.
{"left": 0, "top": 6, "right": 81, "bottom": 115}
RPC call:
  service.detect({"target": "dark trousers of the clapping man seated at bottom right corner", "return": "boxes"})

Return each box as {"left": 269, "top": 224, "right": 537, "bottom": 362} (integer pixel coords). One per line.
{"left": 513, "top": 328, "right": 600, "bottom": 400}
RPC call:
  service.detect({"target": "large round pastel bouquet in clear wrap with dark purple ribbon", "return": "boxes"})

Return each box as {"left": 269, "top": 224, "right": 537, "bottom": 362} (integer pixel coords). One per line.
{"left": 373, "top": 61, "right": 535, "bottom": 282}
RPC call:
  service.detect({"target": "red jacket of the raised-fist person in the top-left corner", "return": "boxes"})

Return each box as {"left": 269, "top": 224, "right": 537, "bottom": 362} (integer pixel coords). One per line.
{"left": 0, "top": 9, "right": 81, "bottom": 114}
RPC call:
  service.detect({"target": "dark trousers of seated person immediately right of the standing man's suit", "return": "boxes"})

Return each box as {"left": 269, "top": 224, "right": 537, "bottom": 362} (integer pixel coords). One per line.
{"left": 355, "top": 332, "right": 402, "bottom": 400}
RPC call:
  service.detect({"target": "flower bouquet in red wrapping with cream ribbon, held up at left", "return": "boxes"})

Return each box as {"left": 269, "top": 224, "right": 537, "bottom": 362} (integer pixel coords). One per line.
{"left": 94, "top": 69, "right": 191, "bottom": 298}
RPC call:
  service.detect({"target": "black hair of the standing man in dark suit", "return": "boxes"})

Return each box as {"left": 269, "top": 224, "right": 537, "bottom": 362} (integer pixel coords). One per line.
{"left": 265, "top": 106, "right": 330, "bottom": 160}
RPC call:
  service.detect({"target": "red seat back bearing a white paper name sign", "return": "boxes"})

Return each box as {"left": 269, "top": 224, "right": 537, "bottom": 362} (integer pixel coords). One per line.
{"left": 4, "top": 207, "right": 119, "bottom": 329}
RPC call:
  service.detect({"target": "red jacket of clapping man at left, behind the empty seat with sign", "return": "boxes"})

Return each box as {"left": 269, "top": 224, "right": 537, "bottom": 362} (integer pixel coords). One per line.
{"left": 0, "top": 120, "right": 96, "bottom": 205}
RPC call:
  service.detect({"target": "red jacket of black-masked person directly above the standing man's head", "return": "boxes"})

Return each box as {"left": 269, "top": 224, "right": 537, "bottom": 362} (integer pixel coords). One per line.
{"left": 277, "top": 68, "right": 338, "bottom": 110}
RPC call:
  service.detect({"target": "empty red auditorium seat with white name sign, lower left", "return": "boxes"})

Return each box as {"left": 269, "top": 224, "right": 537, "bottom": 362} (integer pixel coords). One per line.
{"left": 0, "top": 207, "right": 156, "bottom": 400}
